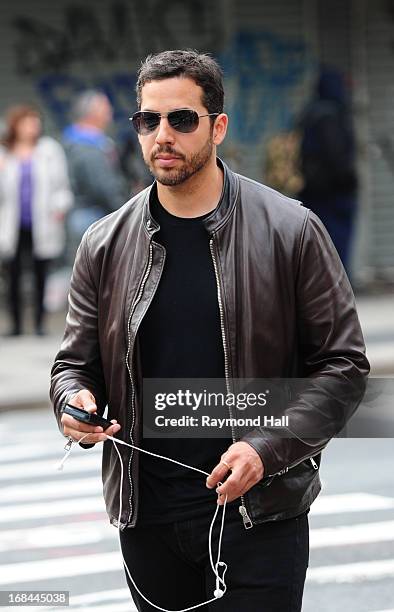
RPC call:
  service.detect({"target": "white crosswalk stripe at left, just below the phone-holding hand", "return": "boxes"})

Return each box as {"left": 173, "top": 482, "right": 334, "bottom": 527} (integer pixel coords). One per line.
{"left": 0, "top": 450, "right": 101, "bottom": 481}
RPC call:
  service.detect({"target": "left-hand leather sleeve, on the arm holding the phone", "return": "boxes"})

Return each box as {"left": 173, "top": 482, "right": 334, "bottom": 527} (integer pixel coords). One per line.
{"left": 50, "top": 230, "right": 107, "bottom": 433}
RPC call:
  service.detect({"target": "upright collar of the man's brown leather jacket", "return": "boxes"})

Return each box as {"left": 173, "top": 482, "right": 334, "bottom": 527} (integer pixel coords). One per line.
{"left": 143, "top": 157, "right": 239, "bottom": 236}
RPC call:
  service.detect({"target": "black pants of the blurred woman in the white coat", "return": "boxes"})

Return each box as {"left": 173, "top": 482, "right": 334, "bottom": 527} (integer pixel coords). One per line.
{"left": 6, "top": 228, "right": 49, "bottom": 333}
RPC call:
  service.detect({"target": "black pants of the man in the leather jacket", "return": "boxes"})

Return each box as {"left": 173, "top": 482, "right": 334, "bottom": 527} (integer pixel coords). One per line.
{"left": 121, "top": 510, "right": 309, "bottom": 612}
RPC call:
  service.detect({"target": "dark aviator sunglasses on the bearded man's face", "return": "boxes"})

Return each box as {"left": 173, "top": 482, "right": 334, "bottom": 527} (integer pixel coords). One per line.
{"left": 130, "top": 108, "right": 220, "bottom": 136}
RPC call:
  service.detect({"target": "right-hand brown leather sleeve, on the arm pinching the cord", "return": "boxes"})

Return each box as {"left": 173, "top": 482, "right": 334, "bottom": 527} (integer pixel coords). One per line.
{"left": 242, "top": 211, "right": 369, "bottom": 476}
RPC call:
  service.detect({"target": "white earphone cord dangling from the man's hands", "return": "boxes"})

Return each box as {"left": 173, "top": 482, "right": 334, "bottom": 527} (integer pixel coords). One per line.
{"left": 57, "top": 434, "right": 227, "bottom": 612}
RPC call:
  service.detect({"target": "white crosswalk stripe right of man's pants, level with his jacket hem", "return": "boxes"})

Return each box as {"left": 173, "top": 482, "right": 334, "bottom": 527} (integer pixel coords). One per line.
{"left": 310, "top": 521, "right": 394, "bottom": 548}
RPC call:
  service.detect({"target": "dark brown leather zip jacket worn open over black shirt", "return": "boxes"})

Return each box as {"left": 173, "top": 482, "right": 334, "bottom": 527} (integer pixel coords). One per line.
{"left": 51, "top": 160, "right": 369, "bottom": 529}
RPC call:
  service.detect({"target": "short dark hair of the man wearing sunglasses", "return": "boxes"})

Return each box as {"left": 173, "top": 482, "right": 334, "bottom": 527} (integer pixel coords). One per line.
{"left": 136, "top": 49, "right": 224, "bottom": 113}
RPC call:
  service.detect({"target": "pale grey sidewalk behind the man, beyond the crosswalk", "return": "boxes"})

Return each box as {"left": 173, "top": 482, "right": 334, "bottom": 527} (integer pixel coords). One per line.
{"left": 0, "top": 294, "right": 394, "bottom": 410}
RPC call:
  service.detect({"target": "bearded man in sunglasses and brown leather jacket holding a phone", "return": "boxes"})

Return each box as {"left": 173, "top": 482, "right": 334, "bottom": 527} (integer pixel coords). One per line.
{"left": 51, "top": 50, "right": 368, "bottom": 612}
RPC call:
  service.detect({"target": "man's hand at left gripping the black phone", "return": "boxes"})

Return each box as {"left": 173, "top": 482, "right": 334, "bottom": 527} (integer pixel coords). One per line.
{"left": 61, "top": 389, "right": 120, "bottom": 444}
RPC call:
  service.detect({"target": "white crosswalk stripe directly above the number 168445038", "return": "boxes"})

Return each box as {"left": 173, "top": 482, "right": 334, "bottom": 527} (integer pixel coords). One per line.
{"left": 0, "top": 551, "right": 123, "bottom": 588}
